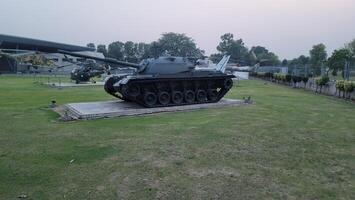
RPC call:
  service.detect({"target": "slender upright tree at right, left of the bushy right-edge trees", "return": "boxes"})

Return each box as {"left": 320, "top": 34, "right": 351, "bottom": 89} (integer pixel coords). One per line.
{"left": 309, "top": 44, "right": 327, "bottom": 75}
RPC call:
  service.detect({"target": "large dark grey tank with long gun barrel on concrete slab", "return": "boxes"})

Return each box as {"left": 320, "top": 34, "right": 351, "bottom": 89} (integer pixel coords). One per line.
{"left": 60, "top": 51, "right": 235, "bottom": 107}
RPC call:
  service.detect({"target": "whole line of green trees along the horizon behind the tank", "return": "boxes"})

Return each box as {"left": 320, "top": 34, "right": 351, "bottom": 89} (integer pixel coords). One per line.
{"left": 87, "top": 32, "right": 355, "bottom": 76}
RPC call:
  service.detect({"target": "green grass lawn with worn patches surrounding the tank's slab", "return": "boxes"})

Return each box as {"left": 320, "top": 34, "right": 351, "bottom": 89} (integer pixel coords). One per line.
{"left": 0, "top": 76, "right": 355, "bottom": 199}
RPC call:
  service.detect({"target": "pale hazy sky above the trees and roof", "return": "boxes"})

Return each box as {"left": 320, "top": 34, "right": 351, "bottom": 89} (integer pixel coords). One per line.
{"left": 0, "top": 0, "right": 355, "bottom": 59}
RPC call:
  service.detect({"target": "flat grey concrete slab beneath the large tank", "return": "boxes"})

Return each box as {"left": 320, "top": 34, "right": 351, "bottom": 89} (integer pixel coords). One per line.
{"left": 55, "top": 99, "right": 247, "bottom": 120}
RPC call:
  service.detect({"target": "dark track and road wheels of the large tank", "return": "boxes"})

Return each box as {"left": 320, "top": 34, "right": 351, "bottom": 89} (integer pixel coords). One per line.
{"left": 105, "top": 75, "right": 234, "bottom": 108}
